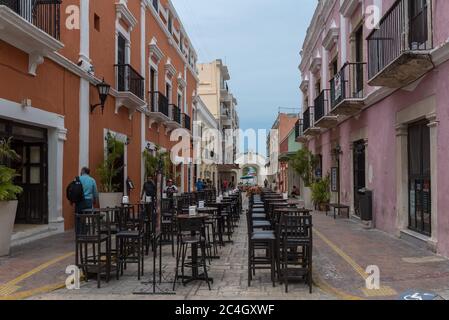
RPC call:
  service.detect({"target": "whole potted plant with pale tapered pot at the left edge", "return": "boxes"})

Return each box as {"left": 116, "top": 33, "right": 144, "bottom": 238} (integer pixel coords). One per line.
{"left": 0, "top": 138, "right": 23, "bottom": 256}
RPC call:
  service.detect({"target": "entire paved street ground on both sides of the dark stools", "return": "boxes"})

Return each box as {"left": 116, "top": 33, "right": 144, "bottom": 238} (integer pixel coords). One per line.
{"left": 0, "top": 212, "right": 449, "bottom": 300}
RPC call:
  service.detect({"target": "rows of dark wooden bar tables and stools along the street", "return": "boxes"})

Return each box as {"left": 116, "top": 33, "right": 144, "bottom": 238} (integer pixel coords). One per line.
{"left": 72, "top": 189, "right": 312, "bottom": 292}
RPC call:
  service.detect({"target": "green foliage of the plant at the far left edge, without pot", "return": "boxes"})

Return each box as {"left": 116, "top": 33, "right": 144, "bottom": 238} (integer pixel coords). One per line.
{"left": 0, "top": 138, "right": 23, "bottom": 201}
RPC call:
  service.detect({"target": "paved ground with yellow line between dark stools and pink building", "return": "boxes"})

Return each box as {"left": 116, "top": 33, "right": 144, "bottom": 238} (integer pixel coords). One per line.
{"left": 314, "top": 212, "right": 449, "bottom": 299}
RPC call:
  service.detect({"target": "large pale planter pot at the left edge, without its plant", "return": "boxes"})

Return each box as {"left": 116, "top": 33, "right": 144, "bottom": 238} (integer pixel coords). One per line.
{"left": 0, "top": 201, "right": 18, "bottom": 257}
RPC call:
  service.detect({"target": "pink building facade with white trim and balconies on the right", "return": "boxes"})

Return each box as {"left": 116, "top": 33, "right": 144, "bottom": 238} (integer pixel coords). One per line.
{"left": 298, "top": 0, "right": 449, "bottom": 256}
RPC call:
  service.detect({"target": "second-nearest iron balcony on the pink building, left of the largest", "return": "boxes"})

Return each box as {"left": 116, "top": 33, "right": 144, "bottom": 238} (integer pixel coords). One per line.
{"left": 330, "top": 62, "right": 366, "bottom": 116}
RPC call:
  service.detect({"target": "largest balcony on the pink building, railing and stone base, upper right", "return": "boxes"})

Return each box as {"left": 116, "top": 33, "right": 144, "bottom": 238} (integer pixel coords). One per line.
{"left": 367, "top": 0, "right": 433, "bottom": 88}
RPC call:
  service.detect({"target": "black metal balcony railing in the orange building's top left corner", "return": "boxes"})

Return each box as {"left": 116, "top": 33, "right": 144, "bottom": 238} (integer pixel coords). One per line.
{"left": 0, "top": 0, "right": 61, "bottom": 40}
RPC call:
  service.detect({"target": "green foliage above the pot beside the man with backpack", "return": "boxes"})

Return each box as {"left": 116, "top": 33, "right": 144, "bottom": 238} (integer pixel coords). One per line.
{"left": 97, "top": 133, "right": 125, "bottom": 193}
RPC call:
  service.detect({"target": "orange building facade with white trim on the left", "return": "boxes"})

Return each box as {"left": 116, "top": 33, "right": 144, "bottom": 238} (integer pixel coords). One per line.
{"left": 0, "top": 0, "right": 198, "bottom": 232}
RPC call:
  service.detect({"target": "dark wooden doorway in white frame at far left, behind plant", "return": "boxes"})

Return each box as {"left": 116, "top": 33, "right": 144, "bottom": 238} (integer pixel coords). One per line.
{"left": 0, "top": 120, "right": 48, "bottom": 224}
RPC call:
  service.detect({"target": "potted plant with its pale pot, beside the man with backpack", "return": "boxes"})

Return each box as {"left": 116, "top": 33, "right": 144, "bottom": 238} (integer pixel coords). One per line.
{"left": 97, "top": 133, "right": 125, "bottom": 208}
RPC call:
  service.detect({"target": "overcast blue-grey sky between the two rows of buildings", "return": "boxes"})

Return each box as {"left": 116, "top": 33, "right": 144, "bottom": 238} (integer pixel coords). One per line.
{"left": 172, "top": 0, "right": 317, "bottom": 152}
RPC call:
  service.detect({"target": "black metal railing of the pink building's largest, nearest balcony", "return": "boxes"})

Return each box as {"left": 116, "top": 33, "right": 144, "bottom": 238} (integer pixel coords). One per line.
{"left": 367, "top": 0, "right": 431, "bottom": 79}
